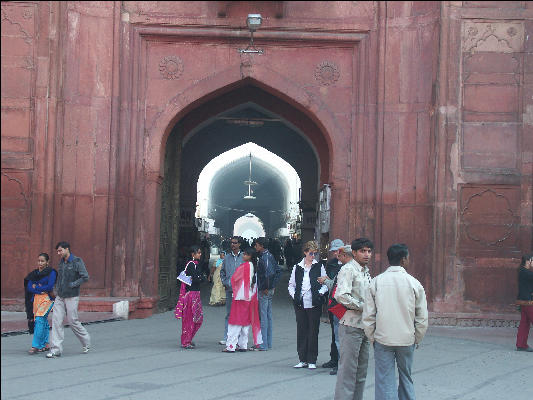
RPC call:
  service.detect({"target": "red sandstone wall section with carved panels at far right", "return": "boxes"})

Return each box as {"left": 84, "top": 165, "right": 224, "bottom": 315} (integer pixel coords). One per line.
{"left": 434, "top": 1, "right": 533, "bottom": 312}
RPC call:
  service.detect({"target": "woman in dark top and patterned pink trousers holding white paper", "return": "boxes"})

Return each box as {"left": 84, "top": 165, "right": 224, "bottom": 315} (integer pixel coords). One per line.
{"left": 174, "top": 246, "right": 204, "bottom": 349}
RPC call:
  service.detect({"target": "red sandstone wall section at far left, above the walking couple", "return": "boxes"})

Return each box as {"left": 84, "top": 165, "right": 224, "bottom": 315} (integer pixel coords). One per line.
{"left": 1, "top": 2, "right": 58, "bottom": 296}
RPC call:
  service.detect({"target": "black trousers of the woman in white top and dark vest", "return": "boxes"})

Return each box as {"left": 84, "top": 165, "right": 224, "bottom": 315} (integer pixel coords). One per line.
{"left": 294, "top": 305, "right": 322, "bottom": 364}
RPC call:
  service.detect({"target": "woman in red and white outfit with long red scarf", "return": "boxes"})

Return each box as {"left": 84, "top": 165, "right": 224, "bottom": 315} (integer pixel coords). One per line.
{"left": 222, "top": 247, "right": 263, "bottom": 353}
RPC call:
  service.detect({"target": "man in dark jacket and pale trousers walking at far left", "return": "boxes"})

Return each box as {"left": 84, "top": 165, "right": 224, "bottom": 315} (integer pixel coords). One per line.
{"left": 46, "top": 242, "right": 91, "bottom": 358}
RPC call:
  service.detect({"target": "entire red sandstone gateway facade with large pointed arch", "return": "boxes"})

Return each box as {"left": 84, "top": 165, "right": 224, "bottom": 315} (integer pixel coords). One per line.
{"left": 1, "top": 1, "right": 533, "bottom": 324}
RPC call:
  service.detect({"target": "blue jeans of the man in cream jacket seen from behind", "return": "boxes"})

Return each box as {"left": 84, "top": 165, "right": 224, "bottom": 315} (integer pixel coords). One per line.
{"left": 374, "top": 342, "right": 415, "bottom": 400}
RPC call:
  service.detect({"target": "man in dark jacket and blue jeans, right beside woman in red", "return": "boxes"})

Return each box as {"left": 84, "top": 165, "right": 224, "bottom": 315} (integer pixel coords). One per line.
{"left": 253, "top": 237, "right": 281, "bottom": 351}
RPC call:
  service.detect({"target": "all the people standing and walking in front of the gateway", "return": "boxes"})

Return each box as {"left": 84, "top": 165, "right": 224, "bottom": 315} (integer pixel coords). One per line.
{"left": 24, "top": 236, "right": 533, "bottom": 400}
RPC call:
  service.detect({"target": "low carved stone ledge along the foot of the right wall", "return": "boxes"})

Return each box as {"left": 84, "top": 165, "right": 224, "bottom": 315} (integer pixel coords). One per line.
{"left": 429, "top": 312, "right": 520, "bottom": 328}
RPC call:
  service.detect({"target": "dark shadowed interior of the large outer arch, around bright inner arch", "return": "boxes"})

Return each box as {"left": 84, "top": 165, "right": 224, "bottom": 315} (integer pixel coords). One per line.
{"left": 155, "top": 81, "right": 330, "bottom": 310}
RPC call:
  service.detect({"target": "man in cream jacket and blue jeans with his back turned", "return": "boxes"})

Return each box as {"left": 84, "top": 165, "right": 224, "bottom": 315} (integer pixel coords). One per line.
{"left": 363, "top": 244, "right": 428, "bottom": 400}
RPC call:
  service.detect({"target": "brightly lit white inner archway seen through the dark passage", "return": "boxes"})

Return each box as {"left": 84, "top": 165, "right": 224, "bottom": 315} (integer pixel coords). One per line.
{"left": 196, "top": 142, "right": 301, "bottom": 237}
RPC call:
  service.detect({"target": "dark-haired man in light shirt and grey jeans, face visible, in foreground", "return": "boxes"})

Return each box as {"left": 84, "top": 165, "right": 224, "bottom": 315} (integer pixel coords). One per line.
{"left": 335, "top": 238, "right": 374, "bottom": 400}
